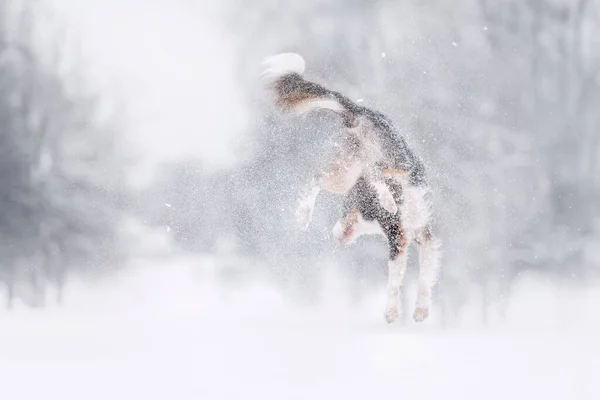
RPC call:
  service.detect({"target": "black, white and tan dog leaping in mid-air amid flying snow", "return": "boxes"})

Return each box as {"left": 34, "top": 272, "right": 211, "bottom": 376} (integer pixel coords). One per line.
{"left": 262, "top": 53, "right": 440, "bottom": 323}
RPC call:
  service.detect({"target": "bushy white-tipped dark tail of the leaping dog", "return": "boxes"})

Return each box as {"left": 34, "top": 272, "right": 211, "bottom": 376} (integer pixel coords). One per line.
{"left": 261, "top": 53, "right": 358, "bottom": 123}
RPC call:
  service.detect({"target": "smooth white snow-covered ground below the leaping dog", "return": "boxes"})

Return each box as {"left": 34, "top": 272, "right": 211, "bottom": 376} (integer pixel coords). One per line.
{"left": 0, "top": 255, "right": 600, "bottom": 400}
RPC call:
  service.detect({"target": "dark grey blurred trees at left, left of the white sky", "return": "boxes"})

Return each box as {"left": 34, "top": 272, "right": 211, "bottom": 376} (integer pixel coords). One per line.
{"left": 0, "top": 0, "right": 127, "bottom": 308}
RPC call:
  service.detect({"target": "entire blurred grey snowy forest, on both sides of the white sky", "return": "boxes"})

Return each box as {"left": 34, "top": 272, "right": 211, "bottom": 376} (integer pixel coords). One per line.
{"left": 0, "top": 0, "right": 600, "bottom": 321}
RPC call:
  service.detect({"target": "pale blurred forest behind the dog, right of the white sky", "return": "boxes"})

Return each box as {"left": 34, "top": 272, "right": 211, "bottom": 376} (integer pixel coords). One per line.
{"left": 144, "top": 0, "right": 600, "bottom": 320}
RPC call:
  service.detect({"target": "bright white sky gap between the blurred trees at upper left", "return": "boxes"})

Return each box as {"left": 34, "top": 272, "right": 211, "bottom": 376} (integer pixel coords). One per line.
{"left": 52, "top": 0, "right": 244, "bottom": 188}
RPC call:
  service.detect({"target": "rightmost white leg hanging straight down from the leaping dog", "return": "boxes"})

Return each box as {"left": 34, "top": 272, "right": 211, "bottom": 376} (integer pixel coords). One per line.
{"left": 413, "top": 226, "right": 440, "bottom": 322}
